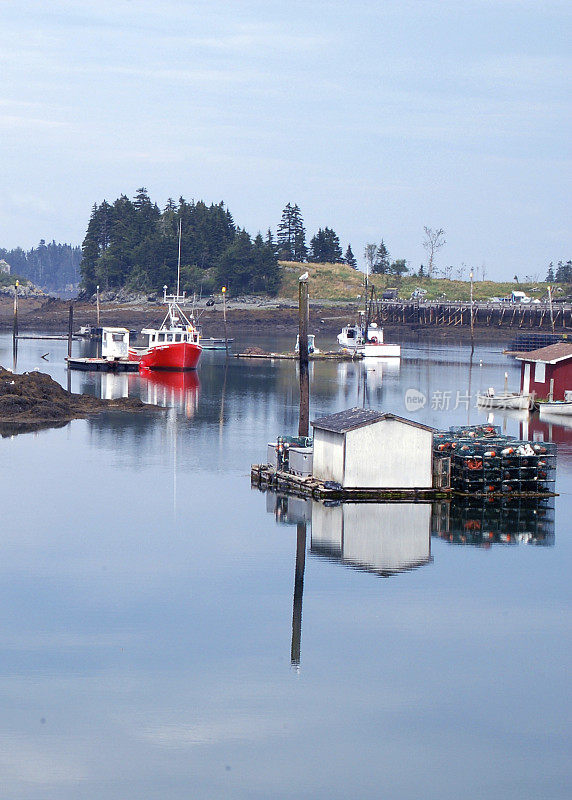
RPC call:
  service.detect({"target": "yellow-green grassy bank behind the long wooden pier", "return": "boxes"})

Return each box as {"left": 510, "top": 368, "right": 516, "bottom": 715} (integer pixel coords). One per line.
{"left": 279, "top": 261, "right": 567, "bottom": 302}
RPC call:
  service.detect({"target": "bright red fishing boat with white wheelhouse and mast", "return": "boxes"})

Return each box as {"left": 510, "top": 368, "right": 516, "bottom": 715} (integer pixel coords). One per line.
{"left": 129, "top": 288, "right": 203, "bottom": 370}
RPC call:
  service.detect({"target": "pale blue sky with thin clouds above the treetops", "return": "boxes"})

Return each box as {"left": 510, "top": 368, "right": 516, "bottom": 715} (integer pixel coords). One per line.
{"left": 0, "top": 0, "right": 572, "bottom": 280}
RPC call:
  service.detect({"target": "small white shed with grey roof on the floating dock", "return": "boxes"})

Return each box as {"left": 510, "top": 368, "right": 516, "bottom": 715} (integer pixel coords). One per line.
{"left": 312, "top": 408, "right": 434, "bottom": 489}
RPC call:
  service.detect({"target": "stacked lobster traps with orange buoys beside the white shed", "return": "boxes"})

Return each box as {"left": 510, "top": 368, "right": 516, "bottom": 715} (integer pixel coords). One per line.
{"left": 433, "top": 425, "right": 556, "bottom": 497}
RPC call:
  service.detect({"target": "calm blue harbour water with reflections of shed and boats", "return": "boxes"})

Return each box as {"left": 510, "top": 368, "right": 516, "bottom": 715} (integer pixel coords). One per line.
{"left": 0, "top": 328, "right": 572, "bottom": 800}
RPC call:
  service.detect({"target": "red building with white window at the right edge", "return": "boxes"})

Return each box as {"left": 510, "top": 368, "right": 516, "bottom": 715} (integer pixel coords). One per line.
{"left": 516, "top": 342, "right": 572, "bottom": 400}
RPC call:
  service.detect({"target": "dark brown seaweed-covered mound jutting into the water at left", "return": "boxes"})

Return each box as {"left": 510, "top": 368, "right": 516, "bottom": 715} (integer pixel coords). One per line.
{"left": 0, "top": 366, "right": 154, "bottom": 422}
